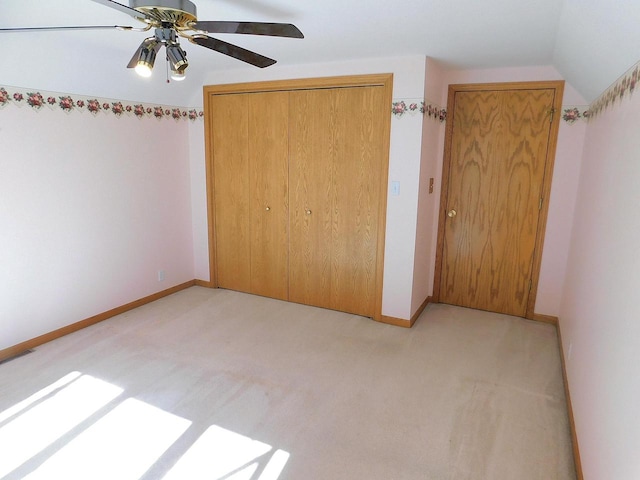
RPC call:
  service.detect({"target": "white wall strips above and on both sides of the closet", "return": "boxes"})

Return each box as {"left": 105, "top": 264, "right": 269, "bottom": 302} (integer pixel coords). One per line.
{"left": 190, "top": 56, "right": 425, "bottom": 319}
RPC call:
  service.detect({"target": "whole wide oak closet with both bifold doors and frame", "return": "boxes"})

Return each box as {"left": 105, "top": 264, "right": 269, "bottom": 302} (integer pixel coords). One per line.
{"left": 205, "top": 75, "right": 391, "bottom": 319}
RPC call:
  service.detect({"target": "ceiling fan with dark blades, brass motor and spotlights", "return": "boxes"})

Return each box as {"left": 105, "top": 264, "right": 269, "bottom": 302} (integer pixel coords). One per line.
{"left": 0, "top": 0, "right": 304, "bottom": 80}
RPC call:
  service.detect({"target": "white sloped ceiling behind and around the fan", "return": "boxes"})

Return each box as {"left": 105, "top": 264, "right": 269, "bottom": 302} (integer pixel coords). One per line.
{"left": 0, "top": 0, "right": 640, "bottom": 105}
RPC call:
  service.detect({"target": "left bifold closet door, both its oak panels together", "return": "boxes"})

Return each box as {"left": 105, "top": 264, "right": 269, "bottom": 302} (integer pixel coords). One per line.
{"left": 211, "top": 92, "right": 289, "bottom": 300}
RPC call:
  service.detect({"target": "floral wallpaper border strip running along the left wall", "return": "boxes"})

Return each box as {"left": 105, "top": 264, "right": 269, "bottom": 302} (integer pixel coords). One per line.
{"left": 0, "top": 86, "right": 204, "bottom": 121}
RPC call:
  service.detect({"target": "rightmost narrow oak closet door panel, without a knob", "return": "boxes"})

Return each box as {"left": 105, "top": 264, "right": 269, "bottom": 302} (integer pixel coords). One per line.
{"left": 331, "top": 87, "right": 388, "bottom": 316}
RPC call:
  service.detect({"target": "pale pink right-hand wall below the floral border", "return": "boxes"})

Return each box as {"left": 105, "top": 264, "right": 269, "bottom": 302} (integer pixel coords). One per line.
{"left": 560, "top": 92, "right": 640, "bottom": 480}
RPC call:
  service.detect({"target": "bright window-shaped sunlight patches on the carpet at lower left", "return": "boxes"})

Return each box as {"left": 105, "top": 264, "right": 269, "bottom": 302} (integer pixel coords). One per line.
{"left": 0, "top": 372, "right": 290, "bottom": 480}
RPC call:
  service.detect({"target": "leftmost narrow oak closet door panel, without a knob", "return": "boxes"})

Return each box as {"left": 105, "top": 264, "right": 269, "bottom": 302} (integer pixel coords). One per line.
{"left": 210, "top": 95, "right": 251, "bottom": 292}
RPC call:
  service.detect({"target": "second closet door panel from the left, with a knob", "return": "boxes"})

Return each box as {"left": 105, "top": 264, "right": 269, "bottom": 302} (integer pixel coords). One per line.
{"left": 248, "top": 92, "right": 289, "bottom": 300}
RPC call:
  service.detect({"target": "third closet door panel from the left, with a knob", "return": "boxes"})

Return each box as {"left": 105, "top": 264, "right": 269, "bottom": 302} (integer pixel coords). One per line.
{"left": 289, "top": 89, "right": 336, "bottom": 307}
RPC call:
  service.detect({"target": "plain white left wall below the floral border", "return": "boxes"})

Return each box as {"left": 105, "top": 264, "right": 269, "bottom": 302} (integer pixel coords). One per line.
{"left": 0, "top": 104, "right": 194, "bottom": 349}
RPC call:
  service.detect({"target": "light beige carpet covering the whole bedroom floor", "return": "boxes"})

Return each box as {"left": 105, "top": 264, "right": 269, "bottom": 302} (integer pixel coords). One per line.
{"left": 0, "top": 287, "right": 575, "bottom": 480}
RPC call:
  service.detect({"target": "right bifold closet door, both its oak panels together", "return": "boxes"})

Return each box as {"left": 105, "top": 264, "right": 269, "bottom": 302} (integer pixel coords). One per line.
{"left": 289, "top": 87, "right": 388, "bottom": 316}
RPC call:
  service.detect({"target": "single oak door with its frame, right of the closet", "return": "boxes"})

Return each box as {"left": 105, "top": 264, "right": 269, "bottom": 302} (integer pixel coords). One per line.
{"left": 439, "top": 85, "right": 562, "bottom": 317}
